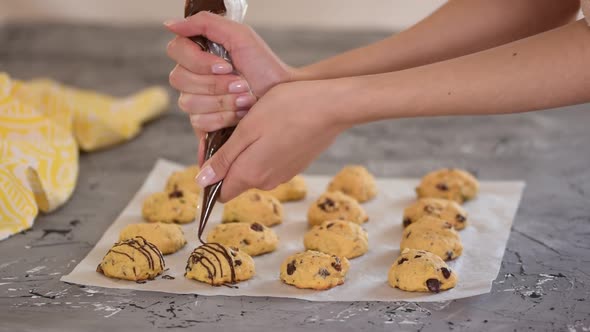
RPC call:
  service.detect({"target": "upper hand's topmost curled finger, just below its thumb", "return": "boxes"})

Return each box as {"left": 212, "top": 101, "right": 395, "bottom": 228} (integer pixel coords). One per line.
{"left": 166, "top": 36, "right": 233, "bottom": 75}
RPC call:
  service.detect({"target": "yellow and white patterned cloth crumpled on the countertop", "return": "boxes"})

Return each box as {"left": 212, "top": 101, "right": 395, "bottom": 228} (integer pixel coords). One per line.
{"left": 0, "top": 73, "right": 168, "bottom": 240}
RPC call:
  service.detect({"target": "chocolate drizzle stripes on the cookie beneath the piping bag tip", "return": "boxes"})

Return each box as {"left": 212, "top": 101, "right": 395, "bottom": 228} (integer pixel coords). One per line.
{"left": 185, "top": 243, "right": 242, "bottom": 285}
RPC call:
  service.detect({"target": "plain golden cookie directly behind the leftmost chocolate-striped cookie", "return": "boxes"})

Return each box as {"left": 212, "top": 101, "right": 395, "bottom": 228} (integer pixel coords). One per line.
{"left": 119, "top": 223, "right": 186, "bottom": 255}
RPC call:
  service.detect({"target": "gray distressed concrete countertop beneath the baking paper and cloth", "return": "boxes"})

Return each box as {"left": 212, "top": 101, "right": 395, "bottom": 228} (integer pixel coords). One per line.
{"left": 0, "top": 25, "right": 590, "bottom": 331}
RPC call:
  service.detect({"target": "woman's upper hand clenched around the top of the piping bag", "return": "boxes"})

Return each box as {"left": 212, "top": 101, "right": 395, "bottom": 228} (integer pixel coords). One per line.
{"left": 165, "top": 12, "right": 294, "bottom": 160}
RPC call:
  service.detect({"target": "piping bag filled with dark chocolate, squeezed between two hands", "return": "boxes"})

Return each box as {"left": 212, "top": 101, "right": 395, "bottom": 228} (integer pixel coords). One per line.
{"left": 184, "top": 0, "right": 248, "bottom": 243}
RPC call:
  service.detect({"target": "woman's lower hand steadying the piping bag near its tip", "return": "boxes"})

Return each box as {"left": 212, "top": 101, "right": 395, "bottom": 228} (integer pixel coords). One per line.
{"left": 197, "top": 81, "right": 354, "bottom": 202}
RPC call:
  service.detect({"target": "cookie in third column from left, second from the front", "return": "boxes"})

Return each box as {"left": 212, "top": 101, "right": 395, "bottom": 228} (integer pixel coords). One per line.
{"left": 303, "top": 220, "right": 369, "bottom": 258}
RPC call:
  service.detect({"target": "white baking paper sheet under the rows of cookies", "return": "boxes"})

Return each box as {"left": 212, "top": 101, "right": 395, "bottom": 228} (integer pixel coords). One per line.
{"left": 61, "top": 160, "right": 524, "bottom": 302}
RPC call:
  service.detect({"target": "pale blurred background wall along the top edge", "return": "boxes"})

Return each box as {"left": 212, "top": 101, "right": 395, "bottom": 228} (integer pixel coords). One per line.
{"left": 0, "top": 0, "right": 445, "bottom": 30}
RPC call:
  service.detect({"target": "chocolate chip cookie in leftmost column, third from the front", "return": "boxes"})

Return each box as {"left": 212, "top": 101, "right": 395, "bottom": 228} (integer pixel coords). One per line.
{"left": 141, "top": 189, "right": 199, "bottom": 224}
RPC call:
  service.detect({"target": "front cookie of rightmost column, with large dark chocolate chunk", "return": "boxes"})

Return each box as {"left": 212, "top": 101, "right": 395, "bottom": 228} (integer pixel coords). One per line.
{"left": 387, "top": 248, "right": 458, "bottom": 293}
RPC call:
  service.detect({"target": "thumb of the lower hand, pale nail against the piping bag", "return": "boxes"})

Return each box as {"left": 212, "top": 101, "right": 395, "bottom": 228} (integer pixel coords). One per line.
{"left": 196, "top": 128, "right": 251, "bottom": 188}
